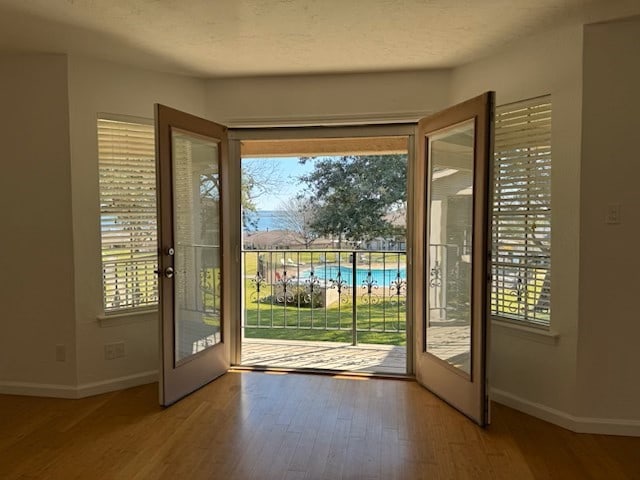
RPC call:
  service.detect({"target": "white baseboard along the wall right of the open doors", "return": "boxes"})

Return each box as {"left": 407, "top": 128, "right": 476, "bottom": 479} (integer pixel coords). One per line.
{"left": 491, "top": 388, "right": 640, "bottom": 437}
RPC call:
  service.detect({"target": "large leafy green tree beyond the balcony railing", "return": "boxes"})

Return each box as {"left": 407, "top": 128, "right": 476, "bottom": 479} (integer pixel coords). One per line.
{"left": 300, "top": 155, "right": 407, "bottom": 248}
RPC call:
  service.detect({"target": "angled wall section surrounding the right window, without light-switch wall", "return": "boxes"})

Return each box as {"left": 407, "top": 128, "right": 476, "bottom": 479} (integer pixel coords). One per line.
{"left": 452, "top": 25, "right": 582, "bottom": 421}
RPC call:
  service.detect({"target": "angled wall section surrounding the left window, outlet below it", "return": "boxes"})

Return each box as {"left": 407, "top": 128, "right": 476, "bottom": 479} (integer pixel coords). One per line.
{"left": 69, "top": 56, "right": 205, "bottom": 394}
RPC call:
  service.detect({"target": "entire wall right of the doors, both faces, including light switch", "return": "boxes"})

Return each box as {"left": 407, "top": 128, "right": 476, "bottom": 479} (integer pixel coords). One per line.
{"left": 452, "top": 12, "right": 640, "bottom": 435}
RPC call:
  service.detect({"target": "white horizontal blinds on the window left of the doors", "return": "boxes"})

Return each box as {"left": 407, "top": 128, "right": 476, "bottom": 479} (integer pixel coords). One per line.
{"left": 98, "top": 119, "right": 158, "bottom": 313}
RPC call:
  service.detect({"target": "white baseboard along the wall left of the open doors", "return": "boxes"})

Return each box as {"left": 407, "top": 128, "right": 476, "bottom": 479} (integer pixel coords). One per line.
{"left": 0, "top": 370, "right": 158, "bottom": 398}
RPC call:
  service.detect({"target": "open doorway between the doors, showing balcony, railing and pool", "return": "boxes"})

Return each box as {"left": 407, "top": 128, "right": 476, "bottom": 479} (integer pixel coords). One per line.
{"left": 240, "top": 135, "right": 409, "bottom": 375}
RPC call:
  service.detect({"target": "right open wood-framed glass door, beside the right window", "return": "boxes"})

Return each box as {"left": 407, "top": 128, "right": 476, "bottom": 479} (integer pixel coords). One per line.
{"left": 414, "top": 92, "right": 495, "bottom": 425}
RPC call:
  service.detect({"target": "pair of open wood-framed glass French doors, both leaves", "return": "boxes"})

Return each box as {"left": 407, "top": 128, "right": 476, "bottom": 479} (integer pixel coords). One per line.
{"left": 156, "top": 92, "right": 495, "bottom": 418}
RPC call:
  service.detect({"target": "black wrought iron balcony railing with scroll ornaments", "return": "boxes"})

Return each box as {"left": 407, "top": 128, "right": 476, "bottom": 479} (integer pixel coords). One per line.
{"left": 243, "top": 250, "right": 407, "bottom": 344}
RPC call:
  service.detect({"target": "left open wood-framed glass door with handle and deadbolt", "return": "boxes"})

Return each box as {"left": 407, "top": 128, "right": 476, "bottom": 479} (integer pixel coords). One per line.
{"left": 155, "top": 105, "right": 230, "bottom": 405}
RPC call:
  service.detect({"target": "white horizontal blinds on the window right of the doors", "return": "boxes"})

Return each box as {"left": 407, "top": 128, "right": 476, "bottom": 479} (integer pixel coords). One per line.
{"left": 491, "top": 96, "right": 551, "bottom": 326}
